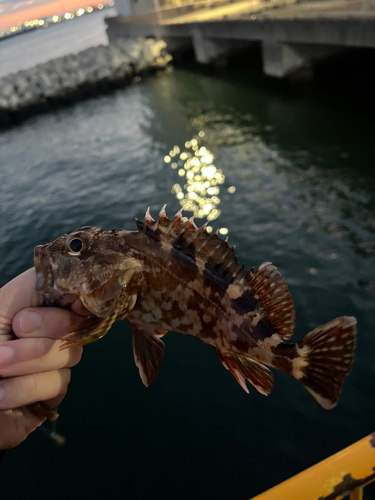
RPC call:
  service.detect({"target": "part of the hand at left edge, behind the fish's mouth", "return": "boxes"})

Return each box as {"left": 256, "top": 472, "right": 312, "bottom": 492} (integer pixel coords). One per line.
{"left": 0, "top": 268, "right": 44, "bottom": 335}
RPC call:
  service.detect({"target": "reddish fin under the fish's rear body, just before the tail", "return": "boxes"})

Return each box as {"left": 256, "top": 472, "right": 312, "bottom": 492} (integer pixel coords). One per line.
{"left": 217, "top": 351, "right": 273, "bottom": 396}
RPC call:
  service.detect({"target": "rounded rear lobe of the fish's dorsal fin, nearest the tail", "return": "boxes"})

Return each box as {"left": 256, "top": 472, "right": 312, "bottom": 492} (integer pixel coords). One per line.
{"left": 247, "top": 262, "right": 296, "bottom": 340}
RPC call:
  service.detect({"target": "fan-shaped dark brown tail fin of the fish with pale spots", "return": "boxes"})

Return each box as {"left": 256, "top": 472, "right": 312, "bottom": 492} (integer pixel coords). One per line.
{"left": 292, "top": 316, "right": 357, "bottom": 410}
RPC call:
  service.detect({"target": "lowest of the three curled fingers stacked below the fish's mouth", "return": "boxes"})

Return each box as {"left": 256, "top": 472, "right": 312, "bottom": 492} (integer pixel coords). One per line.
{"left": 0, "top": 368, "right": 70, "bottom": 410}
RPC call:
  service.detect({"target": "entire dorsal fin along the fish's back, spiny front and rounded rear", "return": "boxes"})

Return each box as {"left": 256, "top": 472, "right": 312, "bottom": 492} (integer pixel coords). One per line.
{"left": 137, "top": 206, "right": 295, "bottom": 340}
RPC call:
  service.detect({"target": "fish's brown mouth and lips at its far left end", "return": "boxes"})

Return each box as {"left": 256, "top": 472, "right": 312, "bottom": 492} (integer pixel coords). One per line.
{"left": 34, "top": 245, "right": 77, "bottom": 307}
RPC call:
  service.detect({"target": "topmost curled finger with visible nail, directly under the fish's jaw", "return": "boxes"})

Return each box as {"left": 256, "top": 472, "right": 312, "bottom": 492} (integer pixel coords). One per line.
{"left": 12, "top": 307, "right": 87, "bottom": 339}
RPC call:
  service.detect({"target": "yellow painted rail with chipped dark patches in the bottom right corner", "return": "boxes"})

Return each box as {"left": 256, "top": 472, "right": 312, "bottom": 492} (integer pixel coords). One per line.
{"left": 252, "top": 434, "right": 375, "bottom": 500}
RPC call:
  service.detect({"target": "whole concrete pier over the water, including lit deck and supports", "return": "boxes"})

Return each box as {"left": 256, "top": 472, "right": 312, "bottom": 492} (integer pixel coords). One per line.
{"left": 107, "top": 0, "right": 375, "bottom": 78}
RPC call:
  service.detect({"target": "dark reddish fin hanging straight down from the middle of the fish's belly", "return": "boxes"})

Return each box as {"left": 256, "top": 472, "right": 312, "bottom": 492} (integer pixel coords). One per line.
{"left": 132, "top": 324, "right": 166, "bottom": 387}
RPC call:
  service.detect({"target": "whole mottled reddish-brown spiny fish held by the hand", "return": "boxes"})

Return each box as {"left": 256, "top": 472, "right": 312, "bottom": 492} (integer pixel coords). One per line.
{"left": 34, "top": 206, "right": 356, "bottom": 409}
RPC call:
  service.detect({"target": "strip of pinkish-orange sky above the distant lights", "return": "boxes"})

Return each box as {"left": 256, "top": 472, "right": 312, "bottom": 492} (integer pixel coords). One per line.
{"left": 0, "top": 0, "right": 100, "bottom": 29}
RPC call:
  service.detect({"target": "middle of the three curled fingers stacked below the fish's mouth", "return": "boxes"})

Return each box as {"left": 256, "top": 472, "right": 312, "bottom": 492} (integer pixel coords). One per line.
{"left": 0, "top": 338, "right": 82, "bottom": 377}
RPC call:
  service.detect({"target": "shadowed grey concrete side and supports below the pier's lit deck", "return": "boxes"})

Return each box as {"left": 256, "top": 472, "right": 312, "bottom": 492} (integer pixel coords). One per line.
{"left": 108, "top": 17, "right": 375, "bottom": 79}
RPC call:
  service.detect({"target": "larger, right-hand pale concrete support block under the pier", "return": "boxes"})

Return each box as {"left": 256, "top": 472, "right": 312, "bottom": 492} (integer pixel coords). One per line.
{"left": 262, "top": 42, "right": 342, "bottom": 78}
